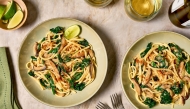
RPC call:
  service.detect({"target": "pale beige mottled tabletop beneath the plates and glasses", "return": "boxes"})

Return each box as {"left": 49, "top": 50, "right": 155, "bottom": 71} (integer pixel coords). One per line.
{"left": 0, "top": 0, "right": 190, "bottom": 109}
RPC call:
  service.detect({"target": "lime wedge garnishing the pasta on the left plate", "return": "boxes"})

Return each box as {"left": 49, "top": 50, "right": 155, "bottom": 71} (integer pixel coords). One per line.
{"left": 64, "top": 25, "right": 81, "bottom": 39}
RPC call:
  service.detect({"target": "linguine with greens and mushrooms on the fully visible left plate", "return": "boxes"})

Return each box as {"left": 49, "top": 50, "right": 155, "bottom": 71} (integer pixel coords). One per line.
{"left": 26, "top": 26, "right": 96, "bottom": 97}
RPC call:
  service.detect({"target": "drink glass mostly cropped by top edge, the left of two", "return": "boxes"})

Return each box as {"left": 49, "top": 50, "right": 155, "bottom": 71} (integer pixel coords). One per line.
{"left": 85, "top": 0, "right": 112, "bottom": 8}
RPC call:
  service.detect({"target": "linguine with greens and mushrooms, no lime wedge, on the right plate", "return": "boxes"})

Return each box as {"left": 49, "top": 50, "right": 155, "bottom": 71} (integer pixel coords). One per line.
{"left": 128, "top": 42, "right": 190, "bottom": 108}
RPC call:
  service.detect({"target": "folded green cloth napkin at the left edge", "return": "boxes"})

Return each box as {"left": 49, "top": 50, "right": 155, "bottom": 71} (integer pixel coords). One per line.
{"left": 0, "top": 47, "right": 21, "bottom": 109}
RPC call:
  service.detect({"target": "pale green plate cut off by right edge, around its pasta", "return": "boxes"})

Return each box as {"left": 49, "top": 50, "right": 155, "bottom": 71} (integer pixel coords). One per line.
{"left": 120, "top": 31, "right": 190, "bottom": 109}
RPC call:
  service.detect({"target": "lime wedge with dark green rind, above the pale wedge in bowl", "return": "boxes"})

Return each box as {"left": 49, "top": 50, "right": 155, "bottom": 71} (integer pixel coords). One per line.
{"left": 2, "top": 1, "right": 17, "bottom": 20}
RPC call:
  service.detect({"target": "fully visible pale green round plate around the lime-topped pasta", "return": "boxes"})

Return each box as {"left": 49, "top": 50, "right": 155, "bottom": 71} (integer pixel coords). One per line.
{"left": 18, "top": 18, "right": 108, "bottom": 107}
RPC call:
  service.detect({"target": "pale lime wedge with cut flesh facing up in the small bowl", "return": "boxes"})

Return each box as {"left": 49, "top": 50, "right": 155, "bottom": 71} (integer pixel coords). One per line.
{"left": 7, "top": 10, "right": 24, "bottom": 29}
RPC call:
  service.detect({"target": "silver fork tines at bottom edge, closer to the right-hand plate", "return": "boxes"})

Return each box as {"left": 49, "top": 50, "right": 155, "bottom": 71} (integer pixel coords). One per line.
{"left": 110, "top": 93, "right": 125, "bottom": 109}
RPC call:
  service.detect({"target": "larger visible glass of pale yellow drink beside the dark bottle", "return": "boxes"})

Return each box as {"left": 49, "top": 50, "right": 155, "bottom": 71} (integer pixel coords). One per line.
{"left": 125, "top": 0, "right": 162, "bottom": 21}
